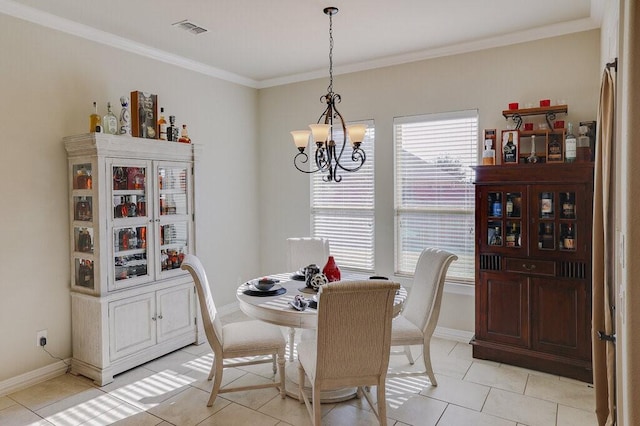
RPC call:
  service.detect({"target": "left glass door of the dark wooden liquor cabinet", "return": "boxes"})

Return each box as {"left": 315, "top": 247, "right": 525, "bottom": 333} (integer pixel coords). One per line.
{"left": 480, "top": 186, "right": 526, "bottom": 253}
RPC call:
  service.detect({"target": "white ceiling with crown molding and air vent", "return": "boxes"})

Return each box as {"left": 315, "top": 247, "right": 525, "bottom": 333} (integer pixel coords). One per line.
{"left": 0, "top": 0, "right": 604, "bottom": 88}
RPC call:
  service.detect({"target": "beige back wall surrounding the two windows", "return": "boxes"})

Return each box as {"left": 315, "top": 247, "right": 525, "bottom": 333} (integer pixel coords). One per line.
{"left": 258, "top": 30, "right": 600, "bottom": 332}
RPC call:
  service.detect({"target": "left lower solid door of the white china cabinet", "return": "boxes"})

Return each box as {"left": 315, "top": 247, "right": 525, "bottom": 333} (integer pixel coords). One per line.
{"left": 109, "top": 292, "right": 156, "bottom": 361}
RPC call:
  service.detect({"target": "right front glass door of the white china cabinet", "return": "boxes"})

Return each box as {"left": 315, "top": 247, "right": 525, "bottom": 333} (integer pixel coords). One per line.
{"left": 156, "top": 162, "right": 192, "bottom": 275}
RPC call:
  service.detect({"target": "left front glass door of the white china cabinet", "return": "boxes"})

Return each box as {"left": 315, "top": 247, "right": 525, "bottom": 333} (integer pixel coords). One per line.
{"left": 109, "top": 160, "right": 153, "bottom": 289}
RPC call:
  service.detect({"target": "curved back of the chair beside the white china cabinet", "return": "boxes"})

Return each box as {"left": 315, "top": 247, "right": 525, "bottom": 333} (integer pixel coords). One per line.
{"left": 180, "top": 254, "right": 224, "bottom": 356}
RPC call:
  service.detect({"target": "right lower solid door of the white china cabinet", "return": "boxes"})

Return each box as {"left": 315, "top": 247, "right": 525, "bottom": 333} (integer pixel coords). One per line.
{"left": 157, "top": 284, "right": 196, "bottom": 343}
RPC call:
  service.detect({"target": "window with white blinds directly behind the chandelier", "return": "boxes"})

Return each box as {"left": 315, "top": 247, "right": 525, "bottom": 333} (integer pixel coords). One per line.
{"left": 311, "top": 120, "right": 375, "bottom": 272}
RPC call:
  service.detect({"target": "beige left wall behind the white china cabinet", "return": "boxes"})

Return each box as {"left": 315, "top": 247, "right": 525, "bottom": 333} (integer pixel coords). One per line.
{"left": 0, "top": 15, "right": 259, "bottom": 382}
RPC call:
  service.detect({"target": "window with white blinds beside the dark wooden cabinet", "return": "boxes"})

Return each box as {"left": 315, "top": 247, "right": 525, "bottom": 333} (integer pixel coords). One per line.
{"left": 393, "top": 110, "right": 478, "bottom": 282}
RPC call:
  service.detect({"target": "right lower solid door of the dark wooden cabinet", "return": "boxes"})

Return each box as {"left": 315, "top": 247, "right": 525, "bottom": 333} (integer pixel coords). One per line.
{"left": 531, "top": 278, "right": 591, "bottom": 359}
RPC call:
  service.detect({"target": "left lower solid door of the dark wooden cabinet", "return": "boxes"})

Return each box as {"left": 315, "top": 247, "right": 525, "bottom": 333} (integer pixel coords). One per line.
{"left": 476, "top": 272, "right": 530, "bottom": 347}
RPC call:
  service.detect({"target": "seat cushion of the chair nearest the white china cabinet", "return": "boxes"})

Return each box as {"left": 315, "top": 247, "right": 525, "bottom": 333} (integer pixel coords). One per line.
{"left": 222, "top": 321, "right": 286, "bottom": 358}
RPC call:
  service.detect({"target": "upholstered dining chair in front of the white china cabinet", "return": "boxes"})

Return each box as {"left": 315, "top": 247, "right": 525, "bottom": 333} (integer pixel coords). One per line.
{"left": 181, "top": 254, "right": 286, "bottom": 407}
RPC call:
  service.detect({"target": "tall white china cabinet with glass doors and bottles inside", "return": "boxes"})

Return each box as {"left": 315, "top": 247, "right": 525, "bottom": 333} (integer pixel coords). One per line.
{"left": 64, "top": 133, "right": 203, "bottom": 386}
